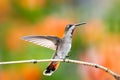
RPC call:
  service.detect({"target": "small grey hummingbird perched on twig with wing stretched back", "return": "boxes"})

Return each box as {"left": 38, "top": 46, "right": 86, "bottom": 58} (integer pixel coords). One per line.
{"left": 22, "top": 23, "right": 86, "bottom": 76}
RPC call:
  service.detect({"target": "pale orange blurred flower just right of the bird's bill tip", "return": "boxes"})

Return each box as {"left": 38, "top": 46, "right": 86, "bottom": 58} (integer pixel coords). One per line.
{"left": 83, "top": 20, "right": 103, "bottom": 42}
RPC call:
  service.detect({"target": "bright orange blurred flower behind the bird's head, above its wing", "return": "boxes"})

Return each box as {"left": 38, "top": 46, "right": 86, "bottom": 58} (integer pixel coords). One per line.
{"left": 34, "top": 17, "right": 72, "bottom": 37}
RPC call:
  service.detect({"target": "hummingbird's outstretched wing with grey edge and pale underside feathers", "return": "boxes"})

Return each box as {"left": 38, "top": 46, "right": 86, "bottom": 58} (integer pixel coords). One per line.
{"left": 22, "top": 36, "right": 61, "bottom": 50}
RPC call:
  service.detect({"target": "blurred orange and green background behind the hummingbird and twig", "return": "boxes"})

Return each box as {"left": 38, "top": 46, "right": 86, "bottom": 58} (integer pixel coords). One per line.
{"left": 0, "top": 0, "right": 120, "bottom": 80}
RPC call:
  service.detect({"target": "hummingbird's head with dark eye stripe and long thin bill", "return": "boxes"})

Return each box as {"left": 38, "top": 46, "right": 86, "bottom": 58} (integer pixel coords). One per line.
{"left": 65, "top": 23, "right": 86, "bottom": 34}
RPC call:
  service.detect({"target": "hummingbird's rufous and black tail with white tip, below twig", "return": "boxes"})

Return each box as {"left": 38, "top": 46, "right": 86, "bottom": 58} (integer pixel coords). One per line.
{"left": 43, "top": 62, "right": 60, "bottom": 76}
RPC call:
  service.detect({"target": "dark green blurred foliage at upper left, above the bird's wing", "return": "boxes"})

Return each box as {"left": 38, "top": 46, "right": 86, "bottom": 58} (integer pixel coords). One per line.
{"left": 11, "top": 0, "right": 59, "bottom": 23}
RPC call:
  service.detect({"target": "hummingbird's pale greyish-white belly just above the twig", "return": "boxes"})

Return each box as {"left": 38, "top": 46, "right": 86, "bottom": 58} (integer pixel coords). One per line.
{"left": 57, "top": 43, "right": 71, "bottom": 59}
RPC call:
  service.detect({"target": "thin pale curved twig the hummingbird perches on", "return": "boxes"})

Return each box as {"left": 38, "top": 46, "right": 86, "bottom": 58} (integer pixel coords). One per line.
{"left": 0, "top": 59, "right": 120, "bottom": 80}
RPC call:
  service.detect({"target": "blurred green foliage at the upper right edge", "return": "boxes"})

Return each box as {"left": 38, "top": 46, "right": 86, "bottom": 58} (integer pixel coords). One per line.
{"left": 104, "top": 0, "right": 120, "bottom": 33}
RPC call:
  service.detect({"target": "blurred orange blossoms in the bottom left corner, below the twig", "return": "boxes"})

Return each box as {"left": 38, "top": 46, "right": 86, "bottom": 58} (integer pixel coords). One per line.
{"left": 0, "top": 65, "right": 41, "bottom": 80}
